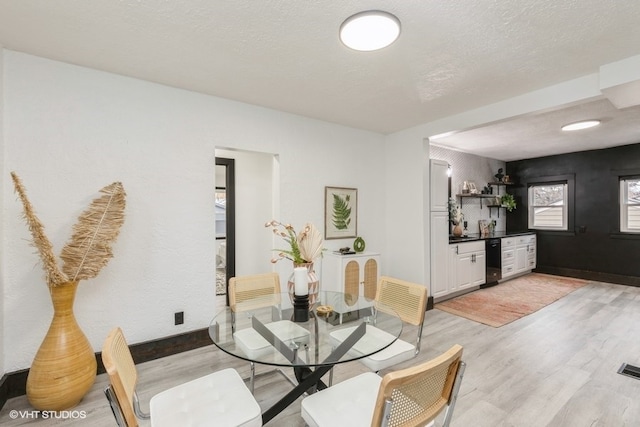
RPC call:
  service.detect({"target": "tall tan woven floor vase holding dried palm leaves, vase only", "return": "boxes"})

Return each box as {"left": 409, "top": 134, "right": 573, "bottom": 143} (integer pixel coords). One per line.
{"left": 27, "top": 282, "right": 97, "bottom": 411}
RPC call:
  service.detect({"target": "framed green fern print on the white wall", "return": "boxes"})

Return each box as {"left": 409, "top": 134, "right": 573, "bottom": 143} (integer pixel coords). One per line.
{"left": 324, "top": 187, "right": 358, "bottom": 239}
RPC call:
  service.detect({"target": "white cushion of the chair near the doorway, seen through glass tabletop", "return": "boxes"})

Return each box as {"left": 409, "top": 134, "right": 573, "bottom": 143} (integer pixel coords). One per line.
{"left": 233, "top": 320, "right": 309, "bottom": 359}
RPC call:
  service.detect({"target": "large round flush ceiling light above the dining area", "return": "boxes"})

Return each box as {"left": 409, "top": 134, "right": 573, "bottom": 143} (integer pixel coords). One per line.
{"left": 340, "top": 10, "right": 400, "bottom": 52}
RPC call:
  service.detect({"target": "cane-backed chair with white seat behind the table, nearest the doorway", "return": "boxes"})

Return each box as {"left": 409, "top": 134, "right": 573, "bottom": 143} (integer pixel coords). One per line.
{"left": 229, "top": 273, "right": 309, "bottom": 393}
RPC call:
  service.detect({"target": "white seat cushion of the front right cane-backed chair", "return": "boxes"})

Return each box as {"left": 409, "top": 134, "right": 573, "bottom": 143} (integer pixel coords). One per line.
{"left": 301, "top": 372, "right": 382, "bottom": 427}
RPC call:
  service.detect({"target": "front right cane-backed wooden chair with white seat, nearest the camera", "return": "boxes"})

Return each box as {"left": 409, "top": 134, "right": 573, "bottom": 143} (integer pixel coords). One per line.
{"left": 301, "top": 344, "right": 466, "bottom": 427}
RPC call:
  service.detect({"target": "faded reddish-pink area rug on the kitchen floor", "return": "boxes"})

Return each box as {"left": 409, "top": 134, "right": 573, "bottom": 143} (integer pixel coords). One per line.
{"left": 435, "top": 273, "right": 589, "bottom": 328}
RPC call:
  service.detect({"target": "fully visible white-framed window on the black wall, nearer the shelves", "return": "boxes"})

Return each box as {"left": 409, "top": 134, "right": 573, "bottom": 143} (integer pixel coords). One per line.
{"left": 529, "top": 182, "right": 568, "bottom": 230}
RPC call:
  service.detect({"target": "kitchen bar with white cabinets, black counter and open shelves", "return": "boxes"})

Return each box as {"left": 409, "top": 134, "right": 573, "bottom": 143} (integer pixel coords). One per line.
{"left": 430, "top": 158, "right": 537, "bottom": 303}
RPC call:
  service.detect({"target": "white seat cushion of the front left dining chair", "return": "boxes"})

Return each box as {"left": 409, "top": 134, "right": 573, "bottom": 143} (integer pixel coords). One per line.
{"left": 150, "top": 369, "right": 262, "bottom": 427}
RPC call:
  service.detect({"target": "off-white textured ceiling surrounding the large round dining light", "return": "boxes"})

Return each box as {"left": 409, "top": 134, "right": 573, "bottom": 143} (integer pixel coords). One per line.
{"left": 0, "top": 0, "right": 640, "bottom": 159}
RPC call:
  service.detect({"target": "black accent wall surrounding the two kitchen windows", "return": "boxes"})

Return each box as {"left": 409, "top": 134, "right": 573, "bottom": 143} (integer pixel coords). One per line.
{"left": 506, "top": 144, "right": 640, "bottom": 286}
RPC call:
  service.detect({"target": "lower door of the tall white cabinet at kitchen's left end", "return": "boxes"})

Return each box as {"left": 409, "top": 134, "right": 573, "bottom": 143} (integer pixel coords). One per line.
{"left": 429, "top": 212, "right": 449, "bottom": 298}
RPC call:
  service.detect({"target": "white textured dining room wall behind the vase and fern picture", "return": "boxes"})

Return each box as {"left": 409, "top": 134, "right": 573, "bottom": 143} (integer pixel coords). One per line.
{"left": 0, "top": 50, "right": 384, "bottom": 372}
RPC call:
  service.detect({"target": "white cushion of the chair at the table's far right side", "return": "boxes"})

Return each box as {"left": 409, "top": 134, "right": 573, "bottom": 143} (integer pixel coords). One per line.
{"left": 330, "top": 325, "right": 415, "bottom": 372}
